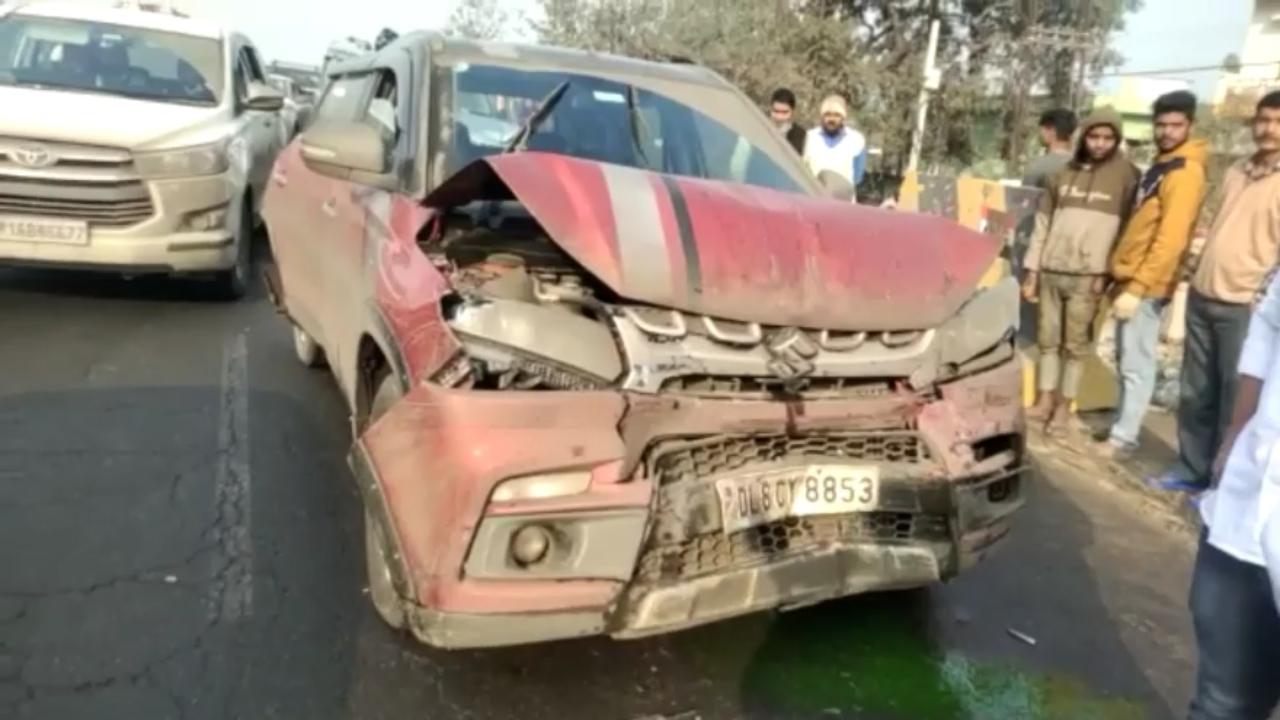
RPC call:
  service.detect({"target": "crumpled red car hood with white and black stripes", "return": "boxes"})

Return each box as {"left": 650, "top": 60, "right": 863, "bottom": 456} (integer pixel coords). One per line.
{"left": 425, "top": 151, "right": 1000, "bottom": 331}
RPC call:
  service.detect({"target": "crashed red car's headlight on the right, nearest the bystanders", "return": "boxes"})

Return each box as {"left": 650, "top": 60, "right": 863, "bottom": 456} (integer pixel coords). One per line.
{"left": 938, "top": 275, "right": 1021, "bottom": 366}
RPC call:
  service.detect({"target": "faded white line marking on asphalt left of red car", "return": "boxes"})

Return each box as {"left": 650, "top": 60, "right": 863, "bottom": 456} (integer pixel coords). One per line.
{"left": 209, "top": 333, "right": 253, "bottom": 621}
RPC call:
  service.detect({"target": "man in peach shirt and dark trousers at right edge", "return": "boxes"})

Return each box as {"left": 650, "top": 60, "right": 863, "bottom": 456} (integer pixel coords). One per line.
{"left": 1162, "top": 91, "right": 1280, "bottom": 492}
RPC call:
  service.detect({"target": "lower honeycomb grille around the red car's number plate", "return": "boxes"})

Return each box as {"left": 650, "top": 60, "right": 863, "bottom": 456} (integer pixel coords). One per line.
{"left": 639, "top": 430, "right": 950, "bottom": 583}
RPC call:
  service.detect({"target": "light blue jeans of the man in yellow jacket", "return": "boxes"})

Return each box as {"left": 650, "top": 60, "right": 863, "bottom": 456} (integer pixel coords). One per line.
{"left": 1111, "top": 297, "right": 1169, "bottom": 446}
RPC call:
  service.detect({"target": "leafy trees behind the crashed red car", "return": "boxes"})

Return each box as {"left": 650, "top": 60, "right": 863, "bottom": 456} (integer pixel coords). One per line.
{"left": 534, "top": 0, "right": 1140, "bottom": 174}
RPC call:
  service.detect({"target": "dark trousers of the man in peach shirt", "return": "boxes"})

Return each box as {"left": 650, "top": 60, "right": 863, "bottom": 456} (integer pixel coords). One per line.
{"left": 1178, "top": 290, "right": 1249, "bottom": 487}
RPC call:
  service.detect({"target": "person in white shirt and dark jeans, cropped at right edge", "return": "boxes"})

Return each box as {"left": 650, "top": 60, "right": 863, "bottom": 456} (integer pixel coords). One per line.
{"left": 1187, "top": 266, "right": 1280, "bottom": 720}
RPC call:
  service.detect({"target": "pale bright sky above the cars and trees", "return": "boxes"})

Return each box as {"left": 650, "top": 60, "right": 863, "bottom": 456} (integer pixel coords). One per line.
{"left": 175, "top": 0, "right": 1253, "bottom": 99}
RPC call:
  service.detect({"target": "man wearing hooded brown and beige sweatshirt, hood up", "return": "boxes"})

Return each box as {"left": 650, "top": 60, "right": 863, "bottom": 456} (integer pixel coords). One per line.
{"left": 1023, "top": 108, "right": 1138, "bottom": 433}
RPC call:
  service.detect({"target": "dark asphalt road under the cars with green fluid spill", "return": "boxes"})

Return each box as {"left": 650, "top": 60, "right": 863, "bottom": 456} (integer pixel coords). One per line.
{"left": 0, "top": 257, "right": 1193, "bottom": 720}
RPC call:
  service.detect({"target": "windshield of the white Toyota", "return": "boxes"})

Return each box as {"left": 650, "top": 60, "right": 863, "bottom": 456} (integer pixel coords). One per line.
{"left": 0, "top": 14, "right": 223, "bottom": 105}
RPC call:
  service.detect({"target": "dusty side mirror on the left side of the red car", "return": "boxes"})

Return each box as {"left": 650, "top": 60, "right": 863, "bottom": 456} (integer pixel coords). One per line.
{"left": 301, "top": 123, "right": 397, "bottom": 190}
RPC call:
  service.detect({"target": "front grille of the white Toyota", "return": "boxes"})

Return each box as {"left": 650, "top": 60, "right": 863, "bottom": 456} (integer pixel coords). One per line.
{"left": 0, "top": 137, "right": 155, "bottom": 228}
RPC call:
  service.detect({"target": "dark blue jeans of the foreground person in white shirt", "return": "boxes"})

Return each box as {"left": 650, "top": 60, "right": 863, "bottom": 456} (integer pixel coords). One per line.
{"left": 1187, "top": 536, "right": 1280, "bottom": 720}
